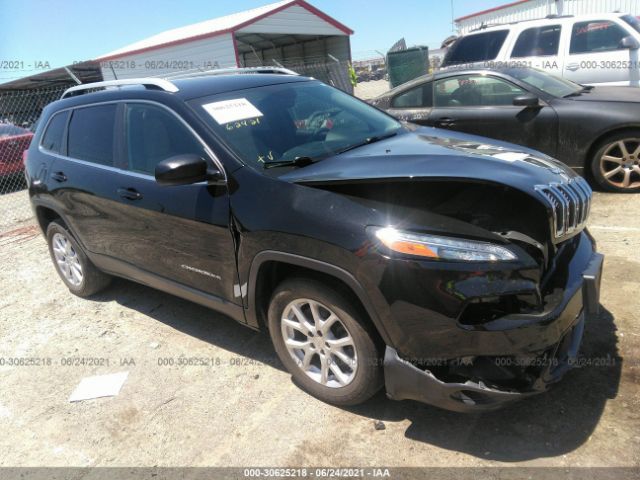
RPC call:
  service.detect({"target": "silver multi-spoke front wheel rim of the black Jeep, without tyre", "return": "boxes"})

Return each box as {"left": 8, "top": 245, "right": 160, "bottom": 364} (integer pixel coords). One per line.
{"left": 281, "top": 299, "right": 358, "bottom": 388}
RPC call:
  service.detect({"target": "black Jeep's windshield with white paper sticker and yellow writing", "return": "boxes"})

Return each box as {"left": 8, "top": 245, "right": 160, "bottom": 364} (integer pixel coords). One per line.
{"left": 191, "top": 81, "right": 402, "bottom": 168}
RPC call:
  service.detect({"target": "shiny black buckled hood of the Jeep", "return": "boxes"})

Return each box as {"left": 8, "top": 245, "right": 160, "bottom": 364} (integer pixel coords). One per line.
{"left": 280, "top": 127, "right": 575, "bottom": 194}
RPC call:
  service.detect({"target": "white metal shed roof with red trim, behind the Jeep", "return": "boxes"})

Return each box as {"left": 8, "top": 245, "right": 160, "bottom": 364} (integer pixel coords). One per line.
{"left": 98, "top": 0, "right": 353, "bottom": 60}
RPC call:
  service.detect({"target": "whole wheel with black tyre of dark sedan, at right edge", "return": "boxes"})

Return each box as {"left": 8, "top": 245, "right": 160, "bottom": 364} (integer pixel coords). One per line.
{"left": 591, "top": 131, "right": 640, "bottom": 193}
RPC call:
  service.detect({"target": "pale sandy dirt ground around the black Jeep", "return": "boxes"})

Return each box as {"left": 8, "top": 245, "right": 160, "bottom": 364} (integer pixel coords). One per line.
{"left": 0, "top": 187, "right": 640, "bottom": 467}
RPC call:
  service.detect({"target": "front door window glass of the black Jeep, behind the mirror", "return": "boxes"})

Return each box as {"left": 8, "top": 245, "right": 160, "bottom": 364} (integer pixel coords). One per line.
{"left": 125, "top": 103, "right": 207, "bottom": 175}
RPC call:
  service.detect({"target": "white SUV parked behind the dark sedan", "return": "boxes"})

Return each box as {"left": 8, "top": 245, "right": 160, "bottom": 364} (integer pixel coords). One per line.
{"left": 442, "top": 13, "right": 640, "bottom": 87}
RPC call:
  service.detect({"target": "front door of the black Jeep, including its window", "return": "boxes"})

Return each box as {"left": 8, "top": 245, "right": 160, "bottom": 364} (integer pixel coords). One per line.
{"left": 110, "top": 102, "right": 237, "bottom": 300}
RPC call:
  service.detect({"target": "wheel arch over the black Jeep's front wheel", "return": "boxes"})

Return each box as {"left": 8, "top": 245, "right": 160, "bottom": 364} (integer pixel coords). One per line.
{"left": 247, "top": 250, "right": 391, "bottom": 345}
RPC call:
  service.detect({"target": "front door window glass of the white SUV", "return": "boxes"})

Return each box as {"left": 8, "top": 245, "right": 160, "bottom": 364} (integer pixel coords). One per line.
{"left": 569, "top": 20, "right": 629, "bottom": 55}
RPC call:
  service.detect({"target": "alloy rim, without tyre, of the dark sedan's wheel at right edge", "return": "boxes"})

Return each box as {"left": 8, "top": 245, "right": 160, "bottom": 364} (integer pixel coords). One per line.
{"left": 600, "top": 138, "right": 640, "bottom": 189}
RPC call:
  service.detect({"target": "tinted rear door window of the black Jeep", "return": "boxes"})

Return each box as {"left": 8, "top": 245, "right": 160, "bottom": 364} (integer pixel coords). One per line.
{"left": 67, "top": 103, "right": 117, "bottom": 166}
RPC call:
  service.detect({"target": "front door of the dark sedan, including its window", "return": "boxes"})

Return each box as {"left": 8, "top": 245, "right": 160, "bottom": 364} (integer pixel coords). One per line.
{"left": 428, "top": 74, "right": 558, "bottom": 155}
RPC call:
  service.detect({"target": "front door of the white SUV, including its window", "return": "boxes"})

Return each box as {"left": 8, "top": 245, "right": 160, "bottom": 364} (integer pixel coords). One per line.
{"left": 564, "top": 20, "right": 638, "bottom": 85}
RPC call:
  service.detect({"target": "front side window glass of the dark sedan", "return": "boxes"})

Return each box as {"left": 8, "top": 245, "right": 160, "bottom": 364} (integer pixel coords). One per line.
{"left": 434, "top": 75, "right": 526, "bottom": 107}
